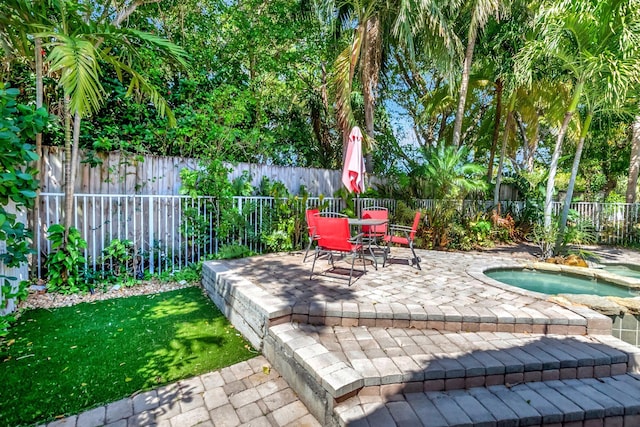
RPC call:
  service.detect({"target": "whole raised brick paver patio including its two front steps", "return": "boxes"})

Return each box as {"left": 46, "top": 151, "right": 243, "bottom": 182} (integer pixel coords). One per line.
{"left": 203, "top": 248, "right": 640, "bottom": 426}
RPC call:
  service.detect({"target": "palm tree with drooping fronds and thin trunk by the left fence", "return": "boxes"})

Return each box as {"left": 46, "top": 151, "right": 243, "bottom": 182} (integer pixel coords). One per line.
{"left": 35, "top": 1, "right": 186, "bottom": 237}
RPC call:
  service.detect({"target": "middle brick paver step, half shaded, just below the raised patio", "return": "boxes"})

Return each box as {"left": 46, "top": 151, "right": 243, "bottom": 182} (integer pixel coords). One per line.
{"left": 269, "top": 323, "right": 637, "bottom": 401}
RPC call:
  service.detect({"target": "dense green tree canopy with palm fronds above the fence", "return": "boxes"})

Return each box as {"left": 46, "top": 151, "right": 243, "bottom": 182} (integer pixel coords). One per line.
{"left": 0, "top": 0, "right": 640, "bottom": 202}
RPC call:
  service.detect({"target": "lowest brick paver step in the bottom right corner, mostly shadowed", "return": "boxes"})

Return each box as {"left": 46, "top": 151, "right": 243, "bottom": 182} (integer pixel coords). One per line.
{"left": 335, "top": 374, "right": 640, "bottom": 427}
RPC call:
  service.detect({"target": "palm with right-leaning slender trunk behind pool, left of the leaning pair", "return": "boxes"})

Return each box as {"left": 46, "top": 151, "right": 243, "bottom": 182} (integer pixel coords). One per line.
{"left": 516, "top": 0, "right": 640, "bottom": 234}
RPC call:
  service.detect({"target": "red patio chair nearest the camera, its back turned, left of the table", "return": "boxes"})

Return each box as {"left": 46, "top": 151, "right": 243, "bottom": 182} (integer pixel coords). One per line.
{"left": 309, "top": 216, "right": 367, "bottom": 286}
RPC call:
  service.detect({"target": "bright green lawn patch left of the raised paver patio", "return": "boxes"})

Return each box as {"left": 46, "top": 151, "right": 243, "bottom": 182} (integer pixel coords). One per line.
{"left": 0, "top": 287, "right": 255, "bottom": 426}
